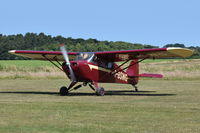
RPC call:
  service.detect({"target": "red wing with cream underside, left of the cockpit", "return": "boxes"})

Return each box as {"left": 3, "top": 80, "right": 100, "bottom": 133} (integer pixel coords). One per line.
{"left": 9, "top": 50, "right": 78, "bottom": 61}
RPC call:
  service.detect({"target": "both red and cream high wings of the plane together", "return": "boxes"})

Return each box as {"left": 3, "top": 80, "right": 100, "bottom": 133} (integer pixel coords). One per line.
{"left": 9, "top": 48, "right": 193, "bottom": 62}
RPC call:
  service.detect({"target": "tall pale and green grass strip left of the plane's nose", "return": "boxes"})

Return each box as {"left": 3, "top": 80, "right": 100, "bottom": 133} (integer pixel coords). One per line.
{"left": 0, "top": 60, "right": 66, "bottom": 79}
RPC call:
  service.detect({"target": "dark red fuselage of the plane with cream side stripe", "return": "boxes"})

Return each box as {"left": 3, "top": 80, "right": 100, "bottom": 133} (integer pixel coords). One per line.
{"left": 62, "top": 60, "right": 138, "bottom": 85}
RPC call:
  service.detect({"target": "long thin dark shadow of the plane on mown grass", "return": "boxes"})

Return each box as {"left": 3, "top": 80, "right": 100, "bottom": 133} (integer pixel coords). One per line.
{"left": 0, "top": 90, "right": 176, "bottom": 96}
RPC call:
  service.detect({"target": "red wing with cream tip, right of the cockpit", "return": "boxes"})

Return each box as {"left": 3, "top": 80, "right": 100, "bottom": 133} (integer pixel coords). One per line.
{"left": 95, "top": 47, "right": 193, "bottom": 62}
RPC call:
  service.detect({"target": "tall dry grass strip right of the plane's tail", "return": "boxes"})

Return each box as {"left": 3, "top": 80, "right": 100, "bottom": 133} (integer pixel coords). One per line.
{"left": 140, "top": 59, "right": 200, "bottom": 80}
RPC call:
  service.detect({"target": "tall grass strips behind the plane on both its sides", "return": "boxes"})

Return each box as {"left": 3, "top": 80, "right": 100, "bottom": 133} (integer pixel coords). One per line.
{"left": 0, "top": 59, "right": 200, "bottom": 80}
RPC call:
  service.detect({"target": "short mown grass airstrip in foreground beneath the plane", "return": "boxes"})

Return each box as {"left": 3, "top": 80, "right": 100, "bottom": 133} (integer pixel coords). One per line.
{"left": 0, "top": 79, "right": 200, "bottom": 133}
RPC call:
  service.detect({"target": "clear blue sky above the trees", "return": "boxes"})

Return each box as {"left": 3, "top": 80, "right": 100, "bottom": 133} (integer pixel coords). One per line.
{"left": 0, "top": 0, "right": 200, "bottom": 47}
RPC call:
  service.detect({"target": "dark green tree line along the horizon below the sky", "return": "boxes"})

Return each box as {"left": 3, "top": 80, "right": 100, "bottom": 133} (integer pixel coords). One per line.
{"left": 0, "top": 33, "right": 200, "bottom": 60}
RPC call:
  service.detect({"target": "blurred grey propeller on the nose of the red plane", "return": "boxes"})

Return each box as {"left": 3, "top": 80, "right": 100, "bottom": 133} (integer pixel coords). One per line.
{"left": 60, "top": 44, "right": 76, "bottom": 82}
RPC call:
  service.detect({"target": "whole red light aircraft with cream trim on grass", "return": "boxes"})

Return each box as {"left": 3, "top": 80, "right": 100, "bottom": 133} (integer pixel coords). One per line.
{"left": 9, "top": 44, "right": 193, "bottom": 96}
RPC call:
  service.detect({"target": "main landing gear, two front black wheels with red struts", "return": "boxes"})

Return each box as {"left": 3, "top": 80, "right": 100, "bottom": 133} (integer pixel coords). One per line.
{"left": 60, "top": 82, "right": 105, "bottom": 96}
